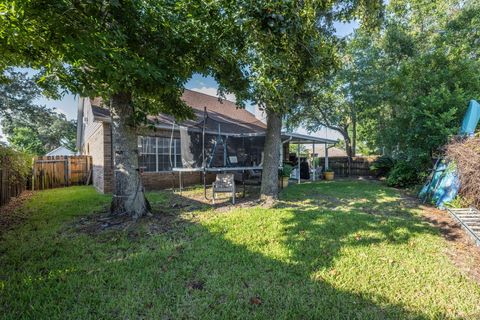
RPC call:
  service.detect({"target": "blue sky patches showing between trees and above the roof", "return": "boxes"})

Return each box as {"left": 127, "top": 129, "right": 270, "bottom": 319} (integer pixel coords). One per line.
{"left": 0, "top": 21, "right": 358, "bottom": 141}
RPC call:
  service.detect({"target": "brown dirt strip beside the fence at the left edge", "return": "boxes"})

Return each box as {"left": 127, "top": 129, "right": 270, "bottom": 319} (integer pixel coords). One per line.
{"left": 0, "top": 191, "right": 33, "bottom": 234}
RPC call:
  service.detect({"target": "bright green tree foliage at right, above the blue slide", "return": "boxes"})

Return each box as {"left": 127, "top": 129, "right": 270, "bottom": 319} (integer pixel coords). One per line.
{"left": 292, "top": 0, "right": 480, "bottom": 184}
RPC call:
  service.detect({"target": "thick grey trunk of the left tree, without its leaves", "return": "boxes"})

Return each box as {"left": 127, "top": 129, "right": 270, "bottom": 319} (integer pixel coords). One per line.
{"left": 110, "top": 93, "right": 150, "bottom": 219}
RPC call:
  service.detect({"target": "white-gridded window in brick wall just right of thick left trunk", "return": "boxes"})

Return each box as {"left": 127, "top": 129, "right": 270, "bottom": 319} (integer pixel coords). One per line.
{"left": 138, "top": 137, "right": 182, "bottom": 172}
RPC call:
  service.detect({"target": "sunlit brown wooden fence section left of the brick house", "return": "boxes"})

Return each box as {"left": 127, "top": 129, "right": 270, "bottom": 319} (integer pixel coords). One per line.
{"left": 32, "top": 156, "right": 92, "bottom": 190}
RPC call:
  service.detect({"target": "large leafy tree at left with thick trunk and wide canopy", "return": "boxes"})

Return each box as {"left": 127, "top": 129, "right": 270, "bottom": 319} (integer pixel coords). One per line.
{"left": 0, "top": 0, "right": 245, "bottom": 218}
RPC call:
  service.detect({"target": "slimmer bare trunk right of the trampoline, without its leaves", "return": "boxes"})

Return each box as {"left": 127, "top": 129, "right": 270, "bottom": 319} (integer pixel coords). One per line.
{"left": 260, "top": 110, "right": 282, "bottom": 205}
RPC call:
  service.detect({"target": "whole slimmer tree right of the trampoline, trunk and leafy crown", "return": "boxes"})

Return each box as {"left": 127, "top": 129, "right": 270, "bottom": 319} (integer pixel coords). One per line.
{"left": 238, "top": 0, "right": 382, "bottom": 203}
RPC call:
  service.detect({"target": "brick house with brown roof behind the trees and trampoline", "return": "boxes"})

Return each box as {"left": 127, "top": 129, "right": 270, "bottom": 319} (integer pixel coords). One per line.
{"left": 77, "top": 90, "right": 335, "bottom": 193}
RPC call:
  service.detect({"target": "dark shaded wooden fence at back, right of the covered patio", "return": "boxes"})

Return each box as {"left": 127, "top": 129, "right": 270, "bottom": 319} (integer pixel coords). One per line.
{"left": 319, "top": 157, "right": 377, "bottom": 177}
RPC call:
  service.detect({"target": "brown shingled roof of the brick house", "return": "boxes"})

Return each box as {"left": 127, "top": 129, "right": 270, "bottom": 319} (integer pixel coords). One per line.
{"left": 90, "top": 89, "right": 266, "bottom": 134}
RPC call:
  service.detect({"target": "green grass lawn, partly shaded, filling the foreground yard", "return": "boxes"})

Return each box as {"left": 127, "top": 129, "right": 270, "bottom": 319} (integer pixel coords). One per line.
{"left": 0, "top": 181, "right": 480, "bottom": 319}
